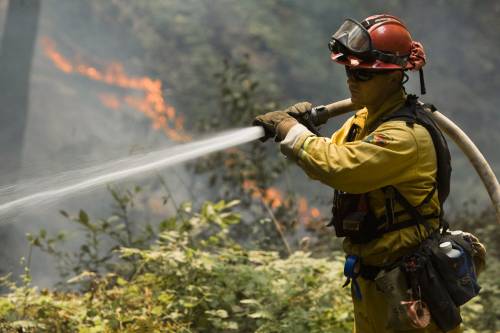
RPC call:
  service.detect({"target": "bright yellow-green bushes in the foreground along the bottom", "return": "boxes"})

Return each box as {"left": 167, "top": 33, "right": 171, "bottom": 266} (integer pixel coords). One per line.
{"left": 0, "top": 201, "right": 352, "bottom": 333}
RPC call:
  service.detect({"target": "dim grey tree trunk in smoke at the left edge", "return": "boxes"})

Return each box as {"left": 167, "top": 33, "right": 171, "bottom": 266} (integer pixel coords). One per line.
{"left": 0, "top": 0, "right": 41, "bottom": 271}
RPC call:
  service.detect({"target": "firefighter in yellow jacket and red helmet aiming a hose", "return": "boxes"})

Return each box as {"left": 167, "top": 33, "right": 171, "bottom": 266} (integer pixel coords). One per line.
{"left": 254, "top": 15, "right": 461, "bottom": 333}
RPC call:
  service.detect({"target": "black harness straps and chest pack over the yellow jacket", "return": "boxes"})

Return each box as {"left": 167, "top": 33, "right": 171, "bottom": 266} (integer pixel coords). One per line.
{"left": 328, "top": 95, "right": 451, "bottom": 244}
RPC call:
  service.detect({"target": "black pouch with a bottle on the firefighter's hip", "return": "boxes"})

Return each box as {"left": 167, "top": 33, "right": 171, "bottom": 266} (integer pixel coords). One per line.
{"left": 431, "top": 234, "right": 481, "bottom": 306}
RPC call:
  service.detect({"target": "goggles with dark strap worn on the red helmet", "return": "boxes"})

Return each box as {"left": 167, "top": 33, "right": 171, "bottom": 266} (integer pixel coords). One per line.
{"left": 328, "top": 19, "right": 407, "bottom": 66}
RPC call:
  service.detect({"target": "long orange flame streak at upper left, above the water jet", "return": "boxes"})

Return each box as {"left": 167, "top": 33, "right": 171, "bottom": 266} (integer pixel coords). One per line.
{"left": 42, "top": 37, "right": 191, "bottom": 141}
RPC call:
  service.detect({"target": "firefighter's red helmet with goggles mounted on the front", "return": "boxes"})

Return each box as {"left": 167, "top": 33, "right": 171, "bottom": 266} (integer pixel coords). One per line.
{"left": 329, "top": 14, "right": 425, "bottom": 70}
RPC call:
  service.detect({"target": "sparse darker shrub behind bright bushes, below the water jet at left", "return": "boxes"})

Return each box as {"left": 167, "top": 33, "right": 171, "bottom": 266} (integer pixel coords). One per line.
{"left": 27, "top": 186, "right": 153, "bottom": 279}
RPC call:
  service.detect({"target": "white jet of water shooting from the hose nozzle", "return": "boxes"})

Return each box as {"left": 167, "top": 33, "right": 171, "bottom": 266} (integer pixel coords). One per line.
{"left": 0, "top": 127, "right": 264, "bottom": 217}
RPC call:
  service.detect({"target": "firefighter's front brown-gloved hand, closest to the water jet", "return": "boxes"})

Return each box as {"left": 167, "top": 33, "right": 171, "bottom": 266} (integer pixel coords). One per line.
{"left": 252, "top": 111, "right": 298, "bottom": 141}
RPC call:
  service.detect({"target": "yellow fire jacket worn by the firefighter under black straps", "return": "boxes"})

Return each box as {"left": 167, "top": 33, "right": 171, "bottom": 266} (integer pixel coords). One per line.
{"left": 281, "top": 91, "right": 440, "bottom": 266}
